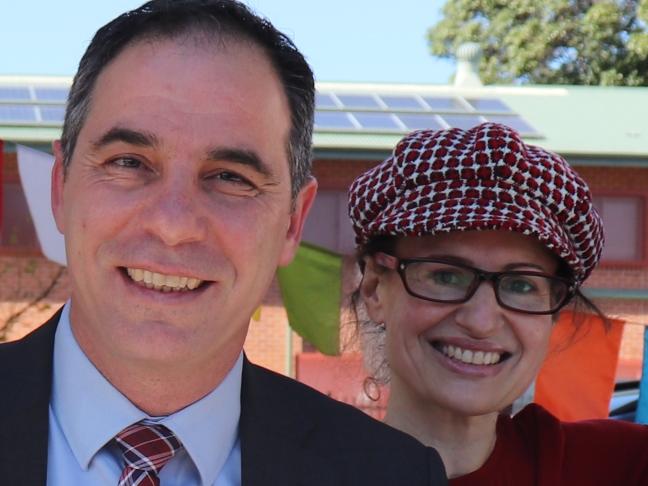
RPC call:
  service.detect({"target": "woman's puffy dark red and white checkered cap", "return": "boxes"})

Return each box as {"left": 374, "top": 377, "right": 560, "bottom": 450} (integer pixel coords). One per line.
{"left": 349, "top": 123, "right": 603, "bottom": 282}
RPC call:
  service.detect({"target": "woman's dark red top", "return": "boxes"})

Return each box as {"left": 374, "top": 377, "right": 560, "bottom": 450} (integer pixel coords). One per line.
{"left": 449, "top": 404, "right": 648, "bottom": 486}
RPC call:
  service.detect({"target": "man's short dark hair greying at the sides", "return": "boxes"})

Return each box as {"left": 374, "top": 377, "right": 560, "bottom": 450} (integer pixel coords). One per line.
{"left": 61, "top": 0, "right": 315, "bottom": 198}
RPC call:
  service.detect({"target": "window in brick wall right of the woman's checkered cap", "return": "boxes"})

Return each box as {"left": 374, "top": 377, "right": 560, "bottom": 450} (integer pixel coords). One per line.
{"left": 594, "top": 196, "right": 645, "bottom": 262}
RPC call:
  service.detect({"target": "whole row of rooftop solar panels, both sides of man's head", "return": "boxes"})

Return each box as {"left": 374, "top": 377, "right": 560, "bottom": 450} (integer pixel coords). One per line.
{"left": 0, "top": 81, "right": 539, "bottom": 136}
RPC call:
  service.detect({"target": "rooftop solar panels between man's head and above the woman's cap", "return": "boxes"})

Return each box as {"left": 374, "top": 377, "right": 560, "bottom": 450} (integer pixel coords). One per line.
{"left": 315, "top": 91, "right": 540, "bottom": 136}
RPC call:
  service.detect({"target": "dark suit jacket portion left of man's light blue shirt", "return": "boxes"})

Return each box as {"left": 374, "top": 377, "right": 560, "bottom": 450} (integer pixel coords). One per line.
{"left": 0, "top": 311, "right": 60, "bottom": 486}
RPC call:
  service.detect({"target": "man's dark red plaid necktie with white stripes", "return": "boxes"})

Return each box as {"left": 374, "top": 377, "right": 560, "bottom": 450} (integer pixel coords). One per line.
{"left": 115, "top": 422, "right": 182, "bottom": 486}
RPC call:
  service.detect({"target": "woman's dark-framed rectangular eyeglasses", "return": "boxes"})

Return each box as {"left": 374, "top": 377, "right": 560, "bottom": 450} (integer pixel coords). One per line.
{"left": 375, "top": 253, "right": 576, "bottom": 314}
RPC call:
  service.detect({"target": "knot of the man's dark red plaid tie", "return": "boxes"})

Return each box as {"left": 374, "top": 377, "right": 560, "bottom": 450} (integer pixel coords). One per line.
{"left": 115, "top": 422, "right": 182, "bottom": 475}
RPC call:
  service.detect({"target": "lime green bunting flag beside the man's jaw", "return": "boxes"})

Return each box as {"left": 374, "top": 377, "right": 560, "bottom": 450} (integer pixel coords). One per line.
{"left": 277, "top": 243, "right": 342, "bottom": 355}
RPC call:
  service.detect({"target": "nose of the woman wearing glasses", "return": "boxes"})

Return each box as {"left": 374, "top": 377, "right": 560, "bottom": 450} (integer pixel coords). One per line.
{"left": 455, "top": 281, "right": 504, "bottom": 339}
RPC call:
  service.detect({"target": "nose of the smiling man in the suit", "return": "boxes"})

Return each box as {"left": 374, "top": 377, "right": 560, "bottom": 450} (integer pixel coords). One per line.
{"left": 141, "top": 181, "right": 208, "bottom": 246}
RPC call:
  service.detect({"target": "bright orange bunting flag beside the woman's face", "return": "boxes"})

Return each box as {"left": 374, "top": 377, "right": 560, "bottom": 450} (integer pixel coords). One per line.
{"left": 533, "top": 312, "right": 624, "bottom": 421}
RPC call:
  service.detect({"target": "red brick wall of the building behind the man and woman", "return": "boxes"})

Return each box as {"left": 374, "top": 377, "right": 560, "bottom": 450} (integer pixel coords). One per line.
{"left": 0, "top": 160, "right": 648, "bottom": 388}
